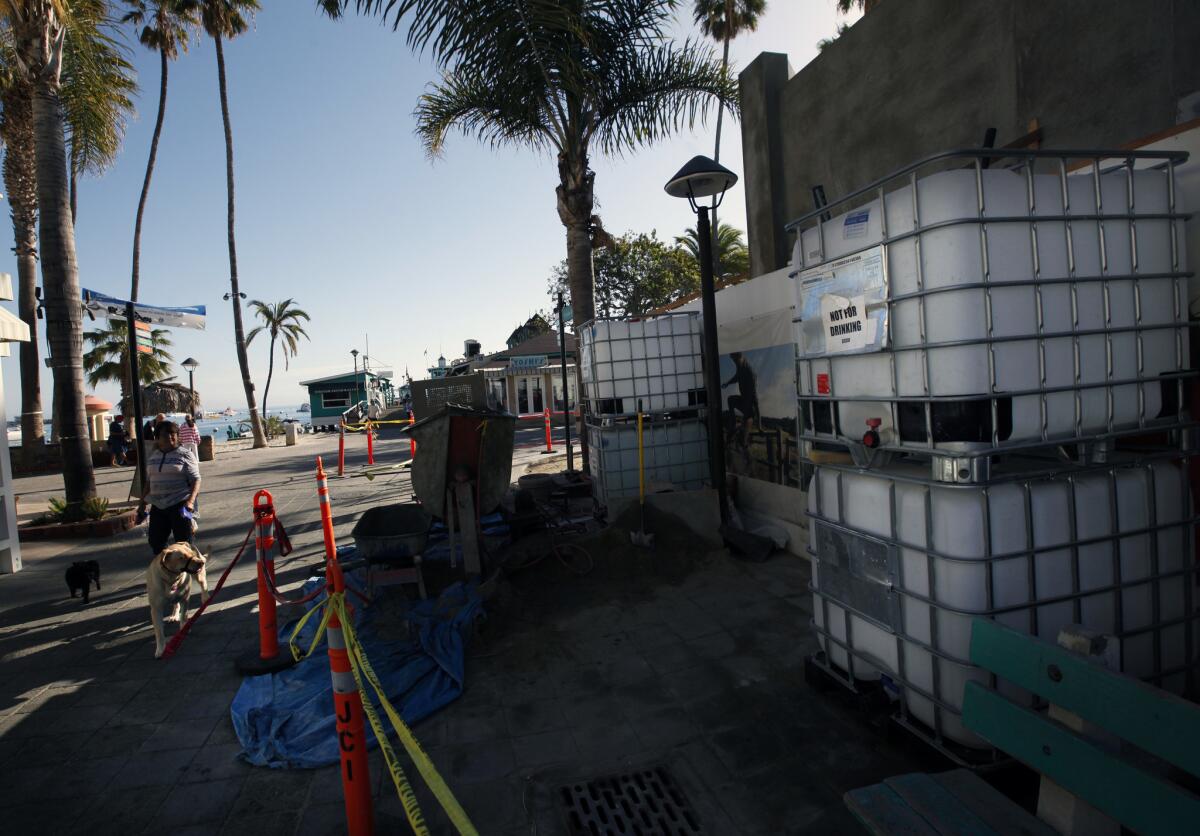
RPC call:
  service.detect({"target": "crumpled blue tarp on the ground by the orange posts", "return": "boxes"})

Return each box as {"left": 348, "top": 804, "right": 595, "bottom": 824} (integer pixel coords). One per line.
{"left": 230, "top": 549, "right": 482, "bottom": 769}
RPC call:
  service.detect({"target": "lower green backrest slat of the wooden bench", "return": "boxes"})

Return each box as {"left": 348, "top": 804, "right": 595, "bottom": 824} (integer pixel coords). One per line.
{"left": 962, "top": 676, "right": 1200, "bottom": 836}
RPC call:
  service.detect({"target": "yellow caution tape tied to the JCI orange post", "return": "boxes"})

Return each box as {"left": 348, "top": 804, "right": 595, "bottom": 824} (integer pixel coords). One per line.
{"left": 288, "top": 593, "right": 479, "bottom": 836}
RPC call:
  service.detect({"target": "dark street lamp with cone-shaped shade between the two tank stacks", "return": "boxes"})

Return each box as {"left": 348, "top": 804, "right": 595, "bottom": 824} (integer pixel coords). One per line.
{"left": 665, "top": 156, "right": 738, "bottom": 524}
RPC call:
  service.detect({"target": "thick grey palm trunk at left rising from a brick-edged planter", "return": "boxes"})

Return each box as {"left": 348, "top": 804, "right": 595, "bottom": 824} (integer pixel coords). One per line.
{"left": 34, "top": 81, "right": 96, "bottom": 508}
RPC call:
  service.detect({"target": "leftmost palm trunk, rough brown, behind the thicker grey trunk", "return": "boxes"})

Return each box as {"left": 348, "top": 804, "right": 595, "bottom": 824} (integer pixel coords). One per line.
{"left": 0, "top": 79, "right": 46, "bottom": 465}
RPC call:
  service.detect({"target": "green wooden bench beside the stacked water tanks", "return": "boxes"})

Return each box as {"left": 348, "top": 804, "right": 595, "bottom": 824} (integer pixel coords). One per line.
{"left": 845, "top": 619, "right": 1200, "bottom": 836}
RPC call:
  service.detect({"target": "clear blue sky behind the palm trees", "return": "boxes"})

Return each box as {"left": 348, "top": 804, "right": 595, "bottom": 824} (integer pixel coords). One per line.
{"left": 0, "top": 0, "right": 857, "bottom": 417}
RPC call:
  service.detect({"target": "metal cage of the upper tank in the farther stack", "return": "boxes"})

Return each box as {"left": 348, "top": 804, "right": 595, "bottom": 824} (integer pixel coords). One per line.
{"left": 580, "top": 311, "right": 704, "bottom": 417}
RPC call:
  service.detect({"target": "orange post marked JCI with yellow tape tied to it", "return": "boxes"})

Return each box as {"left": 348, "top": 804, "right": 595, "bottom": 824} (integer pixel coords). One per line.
{"left": 317, "top": 456, "right": 374, "bottom": 836}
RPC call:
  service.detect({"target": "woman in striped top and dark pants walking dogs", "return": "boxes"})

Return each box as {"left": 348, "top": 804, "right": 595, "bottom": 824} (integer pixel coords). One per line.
{"left": 138, "top": 421, "right": 200, "bottom": 554}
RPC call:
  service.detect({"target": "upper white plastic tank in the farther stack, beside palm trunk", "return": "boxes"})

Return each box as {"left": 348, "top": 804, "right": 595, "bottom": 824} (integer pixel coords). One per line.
{"left": 580, "top": 312, "right": 704, "bottom": 415}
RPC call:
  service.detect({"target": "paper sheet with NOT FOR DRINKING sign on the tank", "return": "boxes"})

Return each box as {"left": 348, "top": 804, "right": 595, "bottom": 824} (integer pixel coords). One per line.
{"left": 797, "top": 246, "right": 888, "bottom": 357}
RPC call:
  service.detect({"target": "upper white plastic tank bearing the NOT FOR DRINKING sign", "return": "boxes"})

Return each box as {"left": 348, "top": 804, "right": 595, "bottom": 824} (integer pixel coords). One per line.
{"left": 794, "top": 168, "right": 1188, "bottom": 441}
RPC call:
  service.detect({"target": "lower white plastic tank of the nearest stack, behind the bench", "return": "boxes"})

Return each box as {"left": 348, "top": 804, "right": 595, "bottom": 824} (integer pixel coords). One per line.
{"left": 809, "top": 461, "right": 1200, "bottom": 747}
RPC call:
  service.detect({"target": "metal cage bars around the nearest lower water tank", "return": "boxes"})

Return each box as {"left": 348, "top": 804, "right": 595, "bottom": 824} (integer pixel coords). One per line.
{"left": 805, "top": 450, "right": 1200, "bottom": 765}
